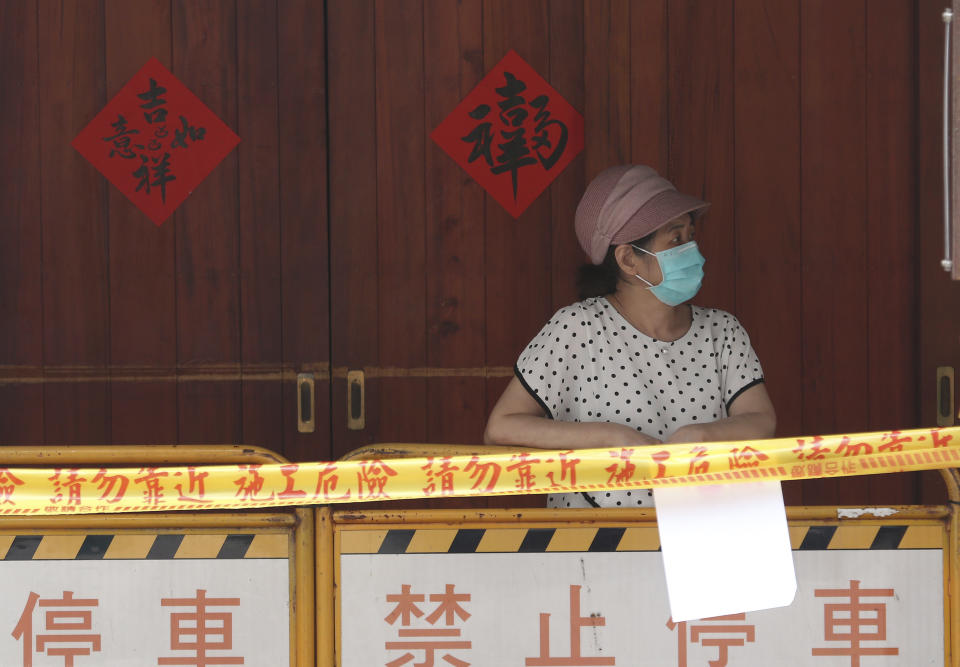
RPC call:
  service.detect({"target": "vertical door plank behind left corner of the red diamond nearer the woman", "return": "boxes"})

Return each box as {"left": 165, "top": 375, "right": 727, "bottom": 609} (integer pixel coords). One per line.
{"left": 423, "top": 0, "right": 486, "bottom": 454}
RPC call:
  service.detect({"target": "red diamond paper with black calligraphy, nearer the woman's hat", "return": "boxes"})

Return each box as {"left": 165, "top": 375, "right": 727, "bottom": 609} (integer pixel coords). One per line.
{"left": 430, "top": 51, "right": 583, "bottom": 218}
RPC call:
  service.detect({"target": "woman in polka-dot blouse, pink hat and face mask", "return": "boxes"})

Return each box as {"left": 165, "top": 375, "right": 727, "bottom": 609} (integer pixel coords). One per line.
{"left": 484, "top": 165, "right": 776, "bottom": 507}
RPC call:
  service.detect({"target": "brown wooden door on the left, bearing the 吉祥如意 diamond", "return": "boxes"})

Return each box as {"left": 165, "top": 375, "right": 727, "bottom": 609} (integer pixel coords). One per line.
{"left": 0, "top": 0, "right": 330, "bottom": 460}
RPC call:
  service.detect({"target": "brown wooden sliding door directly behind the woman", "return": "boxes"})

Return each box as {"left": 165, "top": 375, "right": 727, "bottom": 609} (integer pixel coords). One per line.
{"left": 328, "top": 0, "right": 926, "bottom": 504}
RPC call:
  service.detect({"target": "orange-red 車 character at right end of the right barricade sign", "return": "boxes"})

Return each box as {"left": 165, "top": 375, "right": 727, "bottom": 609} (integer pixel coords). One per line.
{"left": 811, "top": 579, "right": 900, "bottom": 667}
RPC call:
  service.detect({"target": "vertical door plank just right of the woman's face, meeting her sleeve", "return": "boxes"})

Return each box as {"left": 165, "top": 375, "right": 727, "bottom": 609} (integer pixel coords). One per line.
{"left": 736, "top": 0, "right": 804, "bottom": 505}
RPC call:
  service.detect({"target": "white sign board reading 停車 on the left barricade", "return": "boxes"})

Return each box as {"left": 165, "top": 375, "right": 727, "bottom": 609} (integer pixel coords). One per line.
{"left": 0, "top": 558, "right": 290, "bottom": 667}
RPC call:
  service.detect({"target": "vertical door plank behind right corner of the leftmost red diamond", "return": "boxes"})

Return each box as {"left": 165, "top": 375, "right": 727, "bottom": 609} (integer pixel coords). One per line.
{"left": 172, "top": 0, "right": 241, "bottom": 443}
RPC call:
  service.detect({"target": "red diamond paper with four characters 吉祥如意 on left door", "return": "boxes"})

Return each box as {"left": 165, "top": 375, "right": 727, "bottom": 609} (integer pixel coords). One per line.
{"left": 72, "top": 58, "right": 240, "bottom": 225}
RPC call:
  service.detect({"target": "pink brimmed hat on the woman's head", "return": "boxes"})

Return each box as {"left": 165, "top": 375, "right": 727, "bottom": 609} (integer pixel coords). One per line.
{"left": 575, "top": 164, "right": 710, "bottom": 264}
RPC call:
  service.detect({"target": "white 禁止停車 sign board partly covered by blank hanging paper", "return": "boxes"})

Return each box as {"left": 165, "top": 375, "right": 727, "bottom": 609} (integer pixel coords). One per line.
{"left": 339, "top": 549, "right": 944, "bottom": 667}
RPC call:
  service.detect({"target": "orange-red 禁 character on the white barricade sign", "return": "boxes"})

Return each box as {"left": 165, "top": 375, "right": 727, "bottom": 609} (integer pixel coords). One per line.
{"left": 383, "top": 584, "right": 473, "bottom": 667}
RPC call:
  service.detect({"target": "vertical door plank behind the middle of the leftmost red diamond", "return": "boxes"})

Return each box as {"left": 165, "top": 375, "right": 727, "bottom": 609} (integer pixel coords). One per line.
{"left": 105, "top": 0, "right": 177, "bottom": 444}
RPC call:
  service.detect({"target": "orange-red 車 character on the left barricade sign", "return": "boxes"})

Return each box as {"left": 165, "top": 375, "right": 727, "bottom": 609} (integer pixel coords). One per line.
{"left": 157, "top": 589, "right": 244, "bottom": 667}
